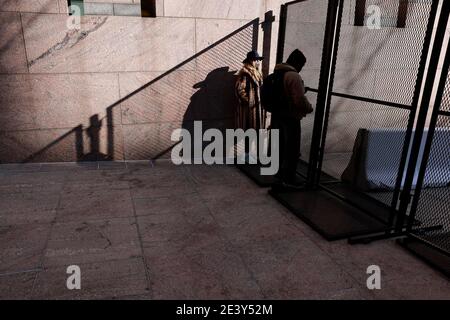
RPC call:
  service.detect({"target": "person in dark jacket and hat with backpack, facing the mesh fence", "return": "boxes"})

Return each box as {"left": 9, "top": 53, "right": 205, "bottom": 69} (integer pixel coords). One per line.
{"left": 271, "top": 49, "right": 313, "bottom": 188}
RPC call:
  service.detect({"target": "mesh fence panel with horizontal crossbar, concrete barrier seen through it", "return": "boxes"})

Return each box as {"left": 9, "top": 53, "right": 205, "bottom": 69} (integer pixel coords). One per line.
{"left": 314, "top": 0, "right": 439, "bottom": 223}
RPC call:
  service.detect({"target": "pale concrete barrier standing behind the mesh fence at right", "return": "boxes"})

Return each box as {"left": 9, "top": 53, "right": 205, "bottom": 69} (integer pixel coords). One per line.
{"left": 341, "top": 128, "right": 450, "bottom": 191}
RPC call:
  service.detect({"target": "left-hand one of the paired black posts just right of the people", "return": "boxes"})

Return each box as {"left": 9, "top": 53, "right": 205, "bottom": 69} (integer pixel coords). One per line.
{"left": 307, "top": 0, "right": 339, "bottom": 188}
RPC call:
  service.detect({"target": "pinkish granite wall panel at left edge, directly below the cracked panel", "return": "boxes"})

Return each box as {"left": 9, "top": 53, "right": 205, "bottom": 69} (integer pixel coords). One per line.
{"left": 0, "top": 73, "right": 120, "bottom": 131}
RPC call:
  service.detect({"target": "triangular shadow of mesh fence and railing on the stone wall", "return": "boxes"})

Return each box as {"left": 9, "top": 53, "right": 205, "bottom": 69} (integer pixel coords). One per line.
{"left": 22, "top": 19, "right": 259, "bottom": 163}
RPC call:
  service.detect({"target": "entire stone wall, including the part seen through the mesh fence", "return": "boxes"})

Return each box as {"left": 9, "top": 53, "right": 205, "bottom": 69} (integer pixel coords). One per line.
{"left": 0, "top": 0, "right": 442, "bottom": 162}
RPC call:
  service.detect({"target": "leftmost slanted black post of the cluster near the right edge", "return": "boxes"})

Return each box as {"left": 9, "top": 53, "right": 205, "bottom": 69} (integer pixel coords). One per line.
{"left": 389, "top": 0, "right": 439, "bottom": 225}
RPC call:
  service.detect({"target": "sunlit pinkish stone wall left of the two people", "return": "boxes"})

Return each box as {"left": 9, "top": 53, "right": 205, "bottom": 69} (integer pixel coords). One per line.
{"left": 0, "top": 0, "right": 288, "bottom": 163}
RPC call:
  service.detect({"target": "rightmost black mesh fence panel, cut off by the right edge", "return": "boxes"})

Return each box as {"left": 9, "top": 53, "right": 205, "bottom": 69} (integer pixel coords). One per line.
{"left": 401, "top": 1, "right": 450, "bottom": 276}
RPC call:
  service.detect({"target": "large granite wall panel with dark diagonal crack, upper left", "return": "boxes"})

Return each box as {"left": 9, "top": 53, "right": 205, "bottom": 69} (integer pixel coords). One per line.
{"left": 23, "top": 14, "right": 195, "bottom": 73}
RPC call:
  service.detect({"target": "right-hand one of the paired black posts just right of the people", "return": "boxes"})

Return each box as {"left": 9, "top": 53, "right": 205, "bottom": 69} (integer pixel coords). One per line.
{"left": 315, "top": 0, "right": 344, "bottom": 185}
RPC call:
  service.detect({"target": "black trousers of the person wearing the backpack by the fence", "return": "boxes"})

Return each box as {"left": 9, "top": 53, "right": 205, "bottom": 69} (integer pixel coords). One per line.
{"left": 271, "top": 115, "right": 301, "bottom": 182}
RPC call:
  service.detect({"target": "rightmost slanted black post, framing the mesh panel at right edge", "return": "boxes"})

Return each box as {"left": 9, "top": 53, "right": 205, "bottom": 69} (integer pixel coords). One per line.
{"left": 406, "top": 28, "right": 450, "bottom": 232}
